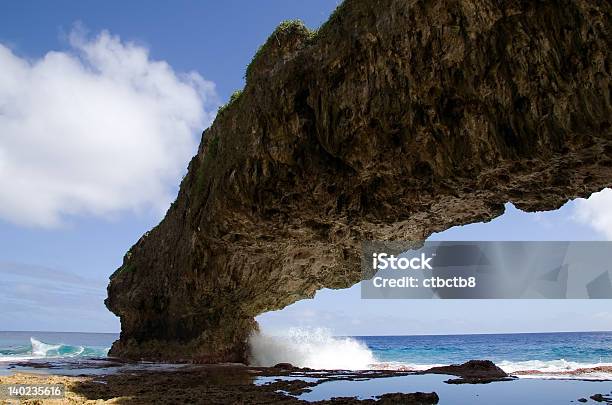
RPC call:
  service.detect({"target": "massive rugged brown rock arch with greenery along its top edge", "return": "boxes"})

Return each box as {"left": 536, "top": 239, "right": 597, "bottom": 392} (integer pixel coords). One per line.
{"left": 106, "top": 0, "right": 612, "bottom": 362}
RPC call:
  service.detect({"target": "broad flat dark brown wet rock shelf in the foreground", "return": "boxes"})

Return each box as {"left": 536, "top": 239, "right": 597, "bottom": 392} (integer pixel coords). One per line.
{"left": 67, "top": 364, "right": 438, "bottom": 405}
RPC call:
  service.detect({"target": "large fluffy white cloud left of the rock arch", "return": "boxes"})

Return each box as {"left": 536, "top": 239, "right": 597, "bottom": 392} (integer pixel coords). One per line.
{"left": 0, "top": 30, "right": 218, "bottom": 226}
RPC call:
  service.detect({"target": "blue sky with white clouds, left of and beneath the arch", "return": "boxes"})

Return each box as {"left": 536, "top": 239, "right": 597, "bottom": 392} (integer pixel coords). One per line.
{"left": 0, "top": 0, "right": 612, "bottom": 335}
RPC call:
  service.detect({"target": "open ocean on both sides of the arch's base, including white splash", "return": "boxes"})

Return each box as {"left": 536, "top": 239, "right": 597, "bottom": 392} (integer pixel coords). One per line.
{"left": 0, "top": 329, "right": 612, "bottom": 379}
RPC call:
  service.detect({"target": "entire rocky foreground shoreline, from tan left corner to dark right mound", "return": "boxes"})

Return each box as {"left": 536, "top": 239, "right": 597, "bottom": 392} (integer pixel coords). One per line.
{"left": 0, "top": 360, "right": 611, "bottom": 405}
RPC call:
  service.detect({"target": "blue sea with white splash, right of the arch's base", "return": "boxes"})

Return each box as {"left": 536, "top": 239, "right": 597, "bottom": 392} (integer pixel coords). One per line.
{"left": 251, "top": 328, "right": 612, "bottom": 379}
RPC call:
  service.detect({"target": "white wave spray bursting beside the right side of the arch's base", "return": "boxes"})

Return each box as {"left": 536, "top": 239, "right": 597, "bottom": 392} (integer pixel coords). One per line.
{"left": 249, "top": 328, "right": 376, "bottom": 370}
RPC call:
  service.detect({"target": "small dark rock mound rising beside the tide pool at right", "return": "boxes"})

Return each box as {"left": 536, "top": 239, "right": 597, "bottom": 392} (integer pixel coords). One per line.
{"left": 423, "top": 360, "right": 514, "bottom": 384}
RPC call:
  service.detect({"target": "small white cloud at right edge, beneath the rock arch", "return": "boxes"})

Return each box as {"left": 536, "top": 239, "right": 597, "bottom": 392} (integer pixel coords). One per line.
{"left": 575, "top": 188, "right": 612, "bottom": 240}
